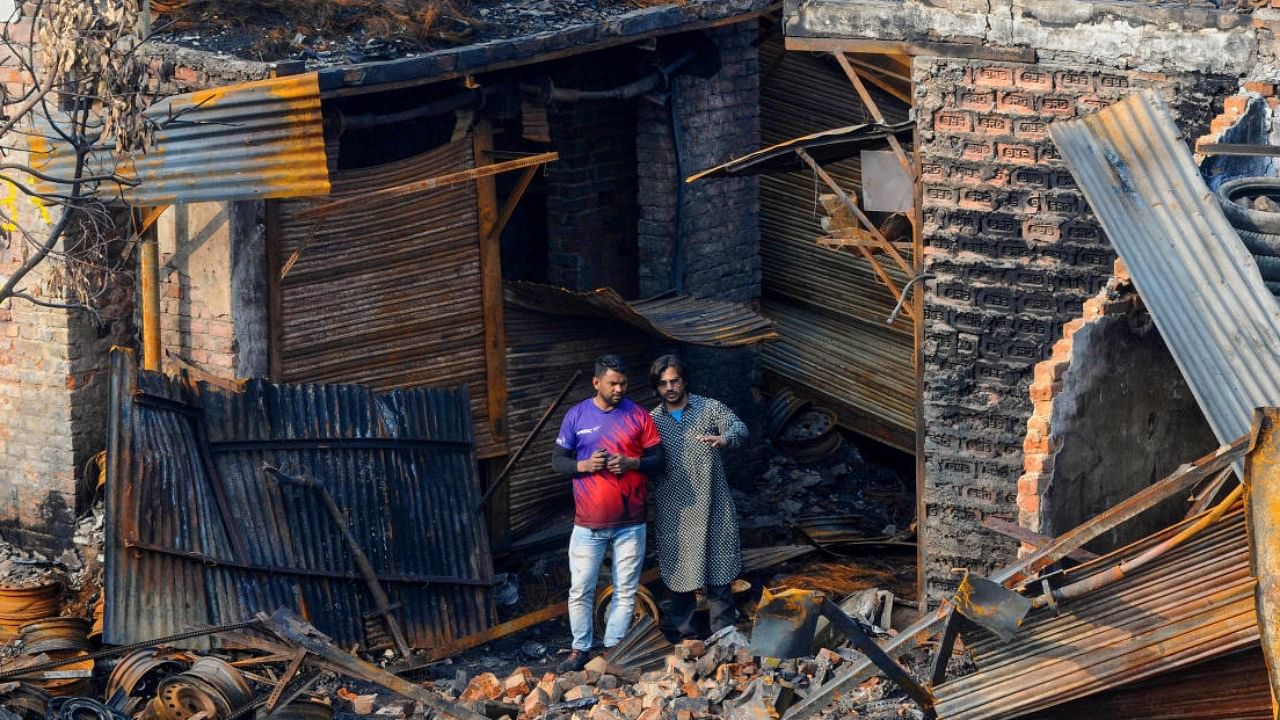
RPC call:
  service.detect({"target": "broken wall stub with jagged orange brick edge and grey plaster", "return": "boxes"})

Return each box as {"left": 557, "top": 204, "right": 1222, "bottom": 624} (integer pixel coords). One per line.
{"left": 1018, "top": 260, "right": 1217, "bottom": 551}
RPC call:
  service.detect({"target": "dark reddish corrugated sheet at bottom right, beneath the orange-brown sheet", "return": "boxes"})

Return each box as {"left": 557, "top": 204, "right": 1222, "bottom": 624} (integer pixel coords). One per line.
{"left": 1036, "top": 650, "right": 1272, "bottom": 720}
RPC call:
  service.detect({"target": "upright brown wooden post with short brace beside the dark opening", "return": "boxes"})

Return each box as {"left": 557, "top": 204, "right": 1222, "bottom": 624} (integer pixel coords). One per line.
{"left": 474, "top": 120, "right": 509, "bottom": 442}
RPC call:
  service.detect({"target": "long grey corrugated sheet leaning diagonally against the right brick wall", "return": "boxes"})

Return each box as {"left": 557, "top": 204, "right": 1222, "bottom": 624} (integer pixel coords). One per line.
{"left": 1050, "top": 91, "right": 1280, "bottom": 468}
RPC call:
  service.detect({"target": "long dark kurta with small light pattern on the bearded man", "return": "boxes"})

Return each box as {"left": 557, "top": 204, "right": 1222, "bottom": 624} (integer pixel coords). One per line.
{"left": 650, "top": 393, "right": 746, "bottom": 592}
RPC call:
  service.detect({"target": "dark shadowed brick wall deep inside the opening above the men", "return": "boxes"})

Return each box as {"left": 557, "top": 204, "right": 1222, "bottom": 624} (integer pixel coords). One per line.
{"left": 547, "top": 79, "right": 639, "bottom": 297}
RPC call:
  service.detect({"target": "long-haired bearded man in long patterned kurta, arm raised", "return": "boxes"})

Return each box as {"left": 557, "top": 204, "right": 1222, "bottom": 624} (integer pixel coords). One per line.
{"left": 649, "top": 355, "right": 746, "bottom": 637}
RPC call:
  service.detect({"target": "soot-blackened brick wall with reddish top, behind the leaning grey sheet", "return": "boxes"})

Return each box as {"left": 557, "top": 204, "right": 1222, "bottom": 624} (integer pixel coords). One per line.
{"left": 914, "top": 58, "right": 1234, "bottom": 602}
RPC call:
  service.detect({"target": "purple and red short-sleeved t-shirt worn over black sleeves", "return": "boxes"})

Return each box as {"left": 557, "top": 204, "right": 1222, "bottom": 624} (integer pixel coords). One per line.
{"left": 556, "top": 397, "right": 662, "bottom": 528}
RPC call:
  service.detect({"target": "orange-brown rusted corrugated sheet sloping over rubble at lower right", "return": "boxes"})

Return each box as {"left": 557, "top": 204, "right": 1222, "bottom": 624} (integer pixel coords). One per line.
{"left": 934, "top": 507, "right": 1265, "bottom": 720}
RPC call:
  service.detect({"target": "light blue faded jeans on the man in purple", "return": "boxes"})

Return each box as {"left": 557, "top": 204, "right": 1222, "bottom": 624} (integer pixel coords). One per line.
{"left": 568, "top": 523, "right": 645, "bottom": 651}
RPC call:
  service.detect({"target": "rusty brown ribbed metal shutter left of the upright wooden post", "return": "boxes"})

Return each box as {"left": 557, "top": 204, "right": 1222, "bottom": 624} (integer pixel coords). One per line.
{"left": 271, "top": 138, "right": 507, "bottom": 457}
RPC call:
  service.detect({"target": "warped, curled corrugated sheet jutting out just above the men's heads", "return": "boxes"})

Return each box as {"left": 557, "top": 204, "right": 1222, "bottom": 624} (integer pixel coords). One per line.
{"left": 504, "top": 282, "right": 778, "bottom": 347}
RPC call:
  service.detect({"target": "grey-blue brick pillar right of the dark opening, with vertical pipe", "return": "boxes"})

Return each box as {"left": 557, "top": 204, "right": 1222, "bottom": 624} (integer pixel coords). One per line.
{"left": 636, "top": 23, "right": 760, "bottom": 301}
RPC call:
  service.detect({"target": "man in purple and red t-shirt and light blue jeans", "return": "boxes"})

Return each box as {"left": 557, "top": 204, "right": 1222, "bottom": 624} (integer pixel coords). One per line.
{"left": 552, "top": 355, "right": 664, "bottom": 673}
